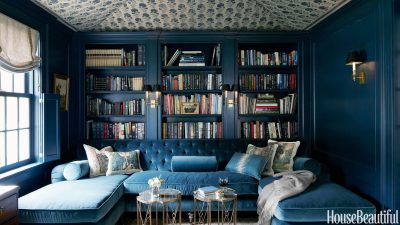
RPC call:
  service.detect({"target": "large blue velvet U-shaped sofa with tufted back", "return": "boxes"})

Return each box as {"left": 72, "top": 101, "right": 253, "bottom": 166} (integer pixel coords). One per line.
{"left": 19, "top": 140, "right": 375, "bottom": 225}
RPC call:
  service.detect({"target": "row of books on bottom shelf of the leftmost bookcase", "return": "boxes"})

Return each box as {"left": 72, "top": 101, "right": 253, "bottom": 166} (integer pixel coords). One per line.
{"left": 86, "top": 120, "right": 144, "bottom": 140}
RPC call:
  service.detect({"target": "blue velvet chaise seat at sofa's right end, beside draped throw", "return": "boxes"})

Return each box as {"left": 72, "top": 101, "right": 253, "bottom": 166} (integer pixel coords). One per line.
{"left": 274, "top": 182, "right": 375, "bottom": 222}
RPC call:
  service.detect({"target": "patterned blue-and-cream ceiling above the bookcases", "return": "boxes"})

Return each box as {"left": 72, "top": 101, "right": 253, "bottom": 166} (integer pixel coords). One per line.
{"left": 32, "top": 0, "right": 349, "bottom": 31}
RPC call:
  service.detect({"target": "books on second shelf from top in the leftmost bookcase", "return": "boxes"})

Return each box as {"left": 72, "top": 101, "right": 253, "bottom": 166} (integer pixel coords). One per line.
{"left": 86, "top": 74, "right": 144, "bottom": 91}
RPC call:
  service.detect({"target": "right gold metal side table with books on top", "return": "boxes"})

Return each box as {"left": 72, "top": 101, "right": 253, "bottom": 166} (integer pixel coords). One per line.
{"left": 193, "top": 189, "right": 237, "bottom": 225}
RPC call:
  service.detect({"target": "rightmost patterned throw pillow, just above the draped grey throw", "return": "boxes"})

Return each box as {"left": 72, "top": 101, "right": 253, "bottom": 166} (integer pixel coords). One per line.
{"left": 268, "top": 140, "right": 300, "bottom": 173}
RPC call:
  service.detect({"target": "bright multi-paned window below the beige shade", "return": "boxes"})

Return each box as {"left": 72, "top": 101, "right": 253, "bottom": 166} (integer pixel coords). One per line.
{"left": 0, "top": 68, "right": 34, "bottom": 173}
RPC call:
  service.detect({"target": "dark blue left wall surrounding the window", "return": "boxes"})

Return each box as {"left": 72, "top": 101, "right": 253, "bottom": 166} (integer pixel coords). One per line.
{"left": 0, "top": 0, "right": 74, "bottom": 195}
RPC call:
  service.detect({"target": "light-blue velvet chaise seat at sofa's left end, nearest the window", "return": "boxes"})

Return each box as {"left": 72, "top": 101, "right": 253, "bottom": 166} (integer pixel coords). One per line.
{"left": 18, "top": 175, "right": 127, "bottom": 223}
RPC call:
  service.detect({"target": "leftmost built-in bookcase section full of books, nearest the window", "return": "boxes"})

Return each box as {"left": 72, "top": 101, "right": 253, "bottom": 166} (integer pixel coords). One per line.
{"left": 85, "top": 44, "right": 146, "bottom": 140}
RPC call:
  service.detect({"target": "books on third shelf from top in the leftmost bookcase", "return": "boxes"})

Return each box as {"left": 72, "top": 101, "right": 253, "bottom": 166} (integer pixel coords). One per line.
{"left": 86, "top": 96, "right": 145, "bottom": 116}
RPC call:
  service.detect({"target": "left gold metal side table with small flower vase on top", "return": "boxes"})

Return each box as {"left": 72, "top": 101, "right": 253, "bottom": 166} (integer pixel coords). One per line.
{"left": 136, "top": 189, "right": 182, "bottom": 225}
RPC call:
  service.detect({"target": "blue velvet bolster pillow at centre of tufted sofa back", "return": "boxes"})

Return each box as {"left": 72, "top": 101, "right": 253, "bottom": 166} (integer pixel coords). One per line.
{"left": 171, "top": 156, "right": 218, "bottom": 172}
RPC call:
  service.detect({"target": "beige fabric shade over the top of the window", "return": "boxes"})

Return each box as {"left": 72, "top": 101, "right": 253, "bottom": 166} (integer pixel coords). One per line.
{"left": 0, "top": 13, "right": 40, "bottom": 73}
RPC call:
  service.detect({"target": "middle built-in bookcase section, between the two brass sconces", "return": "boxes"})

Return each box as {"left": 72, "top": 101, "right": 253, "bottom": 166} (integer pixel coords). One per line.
{"left": 160, "top": 43, "right": 223, "bottom": 139}
